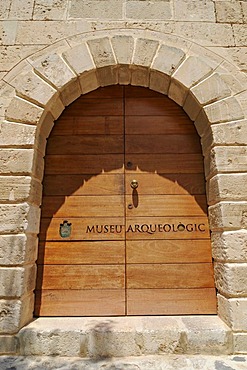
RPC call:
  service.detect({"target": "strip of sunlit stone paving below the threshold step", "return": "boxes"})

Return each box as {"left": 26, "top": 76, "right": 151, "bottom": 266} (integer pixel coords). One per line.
{"left": 0, "top": 355, "right": 247, "bottom": 370}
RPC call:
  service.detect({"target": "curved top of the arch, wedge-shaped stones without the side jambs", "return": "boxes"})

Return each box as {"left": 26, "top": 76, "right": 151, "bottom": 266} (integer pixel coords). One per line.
{"left": 2, "top": 31, "right": 244, "bottom": 151}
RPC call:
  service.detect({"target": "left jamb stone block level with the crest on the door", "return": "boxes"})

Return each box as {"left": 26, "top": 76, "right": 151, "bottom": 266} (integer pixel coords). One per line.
{"left": 0, "top": 203, "right": 40, "bottom": 234}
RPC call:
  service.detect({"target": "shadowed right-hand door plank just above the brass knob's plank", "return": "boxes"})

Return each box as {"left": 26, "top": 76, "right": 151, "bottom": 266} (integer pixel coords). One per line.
{"left": 125, "top": 154, "right": 204, "bottom": 174}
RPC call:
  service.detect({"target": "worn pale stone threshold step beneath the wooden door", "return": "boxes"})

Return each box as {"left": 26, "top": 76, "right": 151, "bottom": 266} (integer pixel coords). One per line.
{"left": 18, "top": 316, "right": 232, "bottom": 358}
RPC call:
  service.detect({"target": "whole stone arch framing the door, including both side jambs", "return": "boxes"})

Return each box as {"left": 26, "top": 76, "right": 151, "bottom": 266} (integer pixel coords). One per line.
{"left": 1, "top": 29, "right": 247, "bottom": 352}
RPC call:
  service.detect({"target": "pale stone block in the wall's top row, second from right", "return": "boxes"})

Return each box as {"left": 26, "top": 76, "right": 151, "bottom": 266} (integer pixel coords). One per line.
{"left": 174, "top": 0, "right": 215, "bottom": 22}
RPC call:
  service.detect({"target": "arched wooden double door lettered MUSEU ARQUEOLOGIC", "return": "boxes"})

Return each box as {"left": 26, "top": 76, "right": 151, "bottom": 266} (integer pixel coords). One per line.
{"left": 35, "top": 86, "right": 216, "bottom": 316}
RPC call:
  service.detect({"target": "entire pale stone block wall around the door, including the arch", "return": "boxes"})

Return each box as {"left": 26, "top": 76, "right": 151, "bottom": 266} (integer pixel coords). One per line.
{"left": 0, "top": 0, "right": 247, "bottom": 353}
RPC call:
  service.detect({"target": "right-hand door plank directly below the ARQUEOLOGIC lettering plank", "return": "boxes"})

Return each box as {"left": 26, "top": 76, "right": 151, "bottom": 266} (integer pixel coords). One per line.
{"left": 126, "top": 239, "right": 212, "bottom": 264}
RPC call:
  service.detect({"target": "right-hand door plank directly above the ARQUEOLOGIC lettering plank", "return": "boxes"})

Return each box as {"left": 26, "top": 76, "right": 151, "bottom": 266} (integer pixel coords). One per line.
{"left": 126, "top": 191, "right": 207, "bottom": 217}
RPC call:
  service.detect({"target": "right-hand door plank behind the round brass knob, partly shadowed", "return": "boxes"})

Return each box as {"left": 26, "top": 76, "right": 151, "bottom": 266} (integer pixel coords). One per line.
{"left": 124, "top": 172, "right": 205, "bottom": 197}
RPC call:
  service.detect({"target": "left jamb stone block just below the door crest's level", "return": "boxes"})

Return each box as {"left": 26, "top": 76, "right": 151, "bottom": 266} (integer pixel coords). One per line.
{"left": 0, "top": 234, "right": 38, "bottom": 266}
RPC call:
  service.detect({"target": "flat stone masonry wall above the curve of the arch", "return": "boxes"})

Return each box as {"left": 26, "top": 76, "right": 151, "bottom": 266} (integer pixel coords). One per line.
{"left": 0, "top": 0, "right": 247, "bottom": 75}
